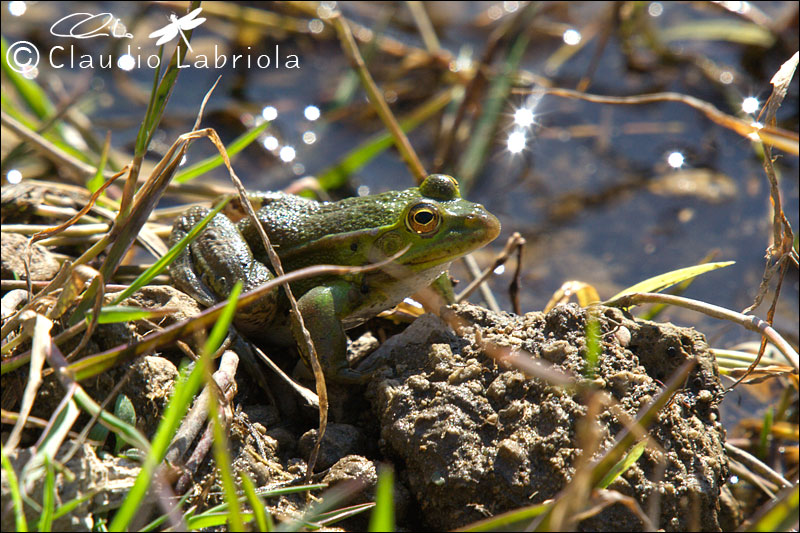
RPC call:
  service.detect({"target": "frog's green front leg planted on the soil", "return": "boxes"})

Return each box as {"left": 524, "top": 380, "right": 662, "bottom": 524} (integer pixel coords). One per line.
{"left": 292, "top": 282, "right": 368, "bottom": 383}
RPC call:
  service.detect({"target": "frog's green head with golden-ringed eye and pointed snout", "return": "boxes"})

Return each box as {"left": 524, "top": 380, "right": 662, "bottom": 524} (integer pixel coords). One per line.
{"left": 371, "top": 174, "right": 500, "bottom": 272}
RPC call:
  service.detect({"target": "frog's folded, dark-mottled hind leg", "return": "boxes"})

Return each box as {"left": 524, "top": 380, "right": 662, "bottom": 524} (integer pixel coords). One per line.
{"left": 169, "top": 207, "right": 278, "bottom": 333}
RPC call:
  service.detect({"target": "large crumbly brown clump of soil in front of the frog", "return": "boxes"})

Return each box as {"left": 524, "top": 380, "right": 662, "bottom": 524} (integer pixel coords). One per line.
{"left": 368, "top": 305, "right": 733, "bottom": 531}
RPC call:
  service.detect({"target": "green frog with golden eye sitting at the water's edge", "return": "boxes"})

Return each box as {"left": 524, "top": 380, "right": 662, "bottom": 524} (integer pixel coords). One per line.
{"left": 169, "top": 174, "right": 500, "bottom": 382}
